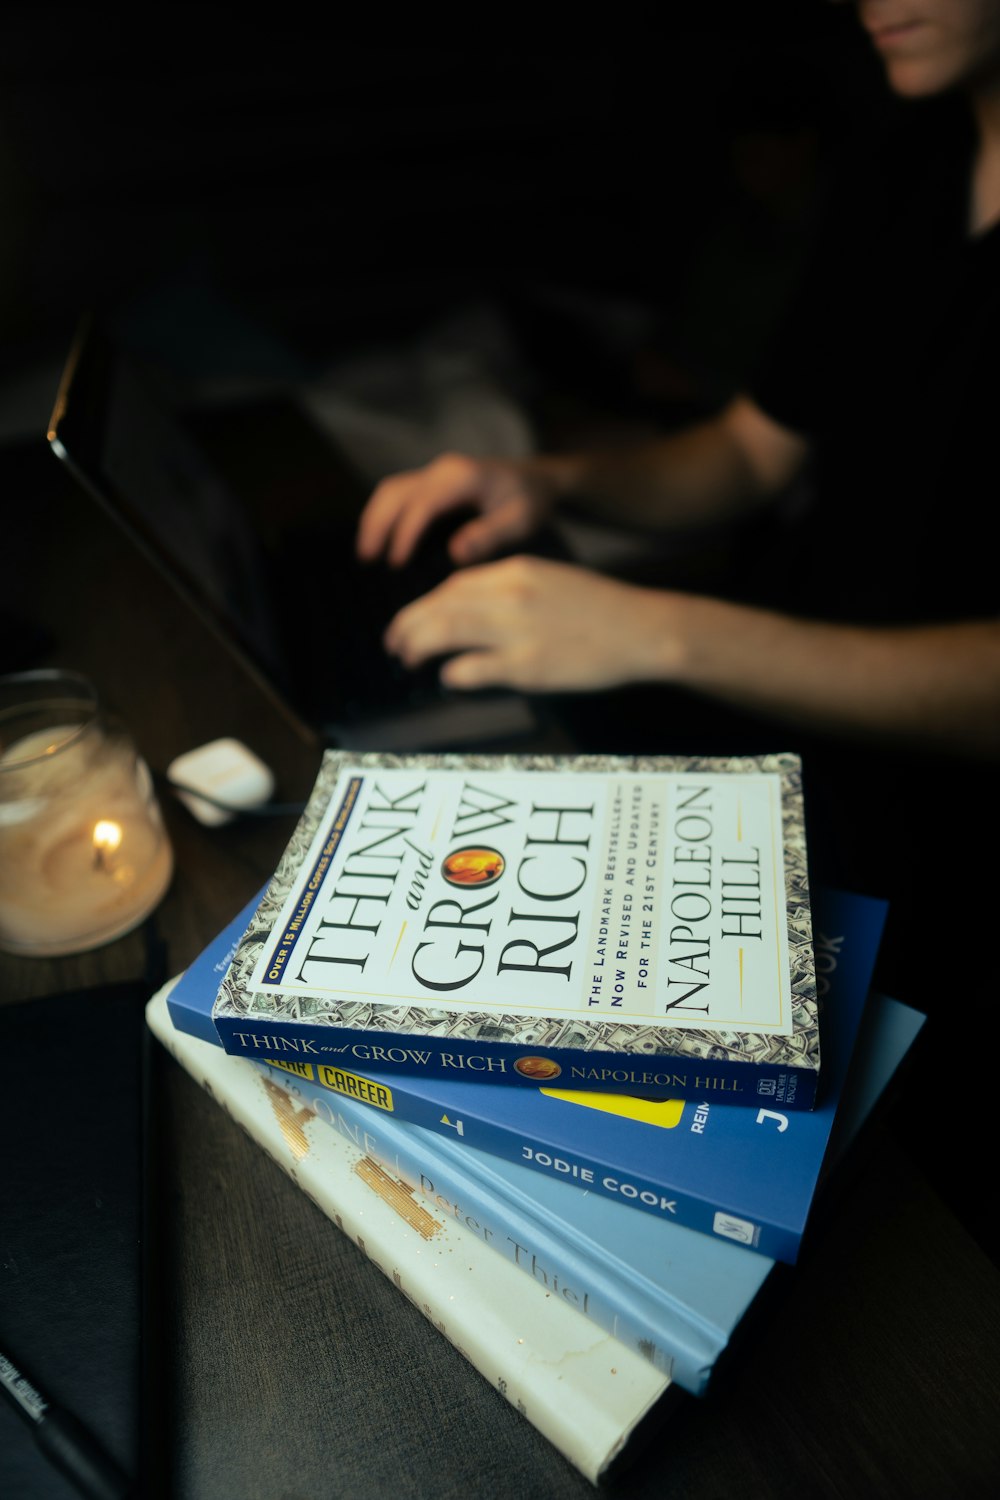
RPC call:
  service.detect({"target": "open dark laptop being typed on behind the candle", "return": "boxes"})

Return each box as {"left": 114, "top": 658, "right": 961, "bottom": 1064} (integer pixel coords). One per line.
{"left": 48, "top": 323, "right": 543, "bottom": 752}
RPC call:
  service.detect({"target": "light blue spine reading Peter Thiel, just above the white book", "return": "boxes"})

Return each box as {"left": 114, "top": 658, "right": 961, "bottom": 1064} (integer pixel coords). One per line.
{"left": 268, "top": 1064, "right": 724, "bottom": 1395}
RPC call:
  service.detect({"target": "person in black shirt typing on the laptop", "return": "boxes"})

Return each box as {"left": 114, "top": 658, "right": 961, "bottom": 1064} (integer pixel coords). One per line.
{"left": 358, "top": 0, "right": 1000, "bottom": 758}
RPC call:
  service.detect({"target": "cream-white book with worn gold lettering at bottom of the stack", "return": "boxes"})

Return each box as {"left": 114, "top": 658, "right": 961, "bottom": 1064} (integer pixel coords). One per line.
{"left": 145, "top": 981, "right": 672, "bottom": 1484}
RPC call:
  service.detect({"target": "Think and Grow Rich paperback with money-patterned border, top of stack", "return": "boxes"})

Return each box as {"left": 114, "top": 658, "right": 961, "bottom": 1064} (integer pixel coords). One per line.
{"left": 213, "top": 752, "right": 820, "bottom": 1112}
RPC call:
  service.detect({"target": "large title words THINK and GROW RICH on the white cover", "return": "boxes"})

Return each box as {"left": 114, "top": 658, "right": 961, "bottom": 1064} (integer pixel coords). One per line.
{"left": 283, "top": 782, "right": 595, "bottom": 993}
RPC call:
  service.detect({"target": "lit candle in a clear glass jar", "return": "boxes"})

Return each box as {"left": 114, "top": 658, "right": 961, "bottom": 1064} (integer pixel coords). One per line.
{"left": 0, "top": 671, "right": 174, "bottom": 954}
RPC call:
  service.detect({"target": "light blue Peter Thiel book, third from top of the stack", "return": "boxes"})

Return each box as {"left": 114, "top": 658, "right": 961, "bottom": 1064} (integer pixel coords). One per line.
{"left": 253, "top": 996, "right": 924, "bottom": 1395}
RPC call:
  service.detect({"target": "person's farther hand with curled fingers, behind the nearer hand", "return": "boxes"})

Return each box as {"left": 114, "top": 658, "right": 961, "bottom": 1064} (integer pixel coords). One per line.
{"left": 357, "top": 453, "right": 556, "bottom": 567}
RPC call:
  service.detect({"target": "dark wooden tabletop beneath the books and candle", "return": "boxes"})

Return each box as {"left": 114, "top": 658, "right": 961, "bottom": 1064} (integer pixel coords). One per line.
{"left": 0, "top": 426, "right": 1000, "bottom": 1500}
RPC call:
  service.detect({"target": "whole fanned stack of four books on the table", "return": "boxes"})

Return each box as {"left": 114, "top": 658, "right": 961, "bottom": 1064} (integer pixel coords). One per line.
{"left": 147, "top": 752, "right": 922, "bottom": 1482}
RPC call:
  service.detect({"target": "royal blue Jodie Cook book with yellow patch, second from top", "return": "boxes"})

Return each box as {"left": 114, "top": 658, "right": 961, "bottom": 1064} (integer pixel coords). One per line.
{"left": 168, "top": 891, "right": 886, "bottom": 1262}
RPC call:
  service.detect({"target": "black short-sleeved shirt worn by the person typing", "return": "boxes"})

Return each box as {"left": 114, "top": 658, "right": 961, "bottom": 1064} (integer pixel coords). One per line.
{"left": 754, "top": 101, "right": 1000, "bottom": 624}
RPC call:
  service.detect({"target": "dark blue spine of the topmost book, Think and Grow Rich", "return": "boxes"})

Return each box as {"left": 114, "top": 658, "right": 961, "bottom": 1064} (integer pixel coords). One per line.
{"left": 213, "top": 1016, "right": 819, "bottom": 1110}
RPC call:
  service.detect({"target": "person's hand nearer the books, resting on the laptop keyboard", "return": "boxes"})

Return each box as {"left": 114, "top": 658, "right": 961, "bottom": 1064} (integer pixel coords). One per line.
{"left": 385, "top": 557, "right": 681, "bottom": 692}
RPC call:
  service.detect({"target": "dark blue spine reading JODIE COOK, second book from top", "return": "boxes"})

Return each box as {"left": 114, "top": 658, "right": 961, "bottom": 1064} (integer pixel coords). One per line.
{"left": 267, "top": 1062, "right": 802, "bottom": 1263}
